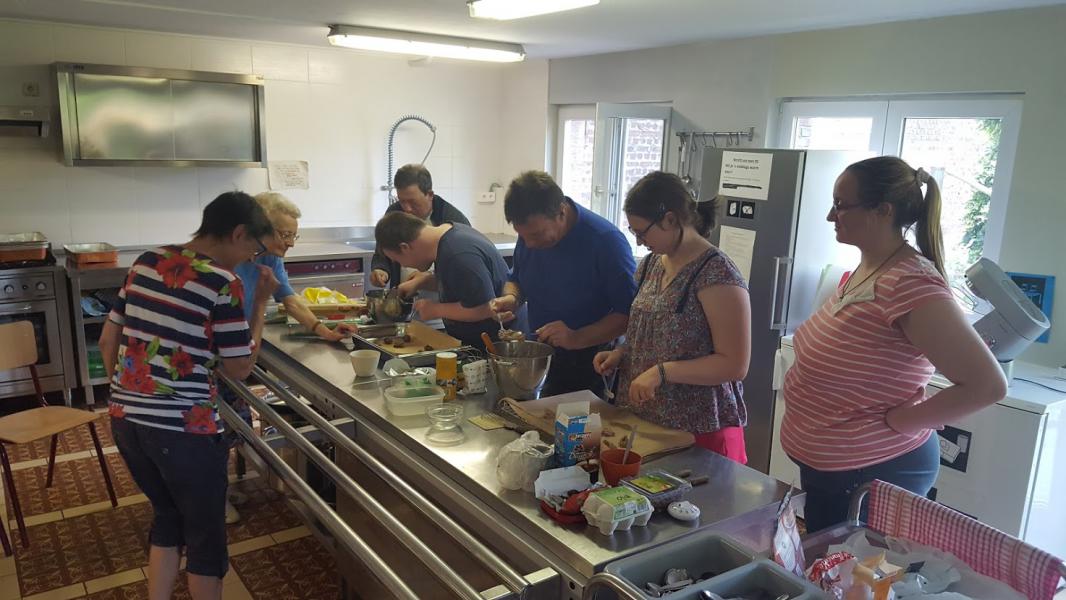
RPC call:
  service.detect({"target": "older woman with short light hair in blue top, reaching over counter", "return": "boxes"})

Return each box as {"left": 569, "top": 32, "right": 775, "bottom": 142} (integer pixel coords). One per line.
{"left": 237, "top": 192, "right": 355, "bottom": 342}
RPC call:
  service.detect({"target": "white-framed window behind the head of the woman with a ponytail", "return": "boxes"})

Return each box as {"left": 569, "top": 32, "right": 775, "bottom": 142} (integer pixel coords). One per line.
{"left": 778, "top": 95, "right": 1021, "bottom": 281}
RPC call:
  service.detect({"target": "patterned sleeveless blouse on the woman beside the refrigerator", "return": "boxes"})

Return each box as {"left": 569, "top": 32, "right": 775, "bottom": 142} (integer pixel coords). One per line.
{"left": 618, "top": 248, "right": 747, "bottom": 434}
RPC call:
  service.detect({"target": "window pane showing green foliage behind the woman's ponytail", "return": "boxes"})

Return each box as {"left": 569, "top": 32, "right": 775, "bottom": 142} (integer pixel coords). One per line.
{"left": 900, "top": 118, "right": 1002, "bottom": 281}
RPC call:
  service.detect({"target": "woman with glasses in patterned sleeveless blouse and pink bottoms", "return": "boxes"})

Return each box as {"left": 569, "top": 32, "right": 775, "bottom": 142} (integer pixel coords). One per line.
{"left": 594, "top": 172, "right": 752, "bottom": 464}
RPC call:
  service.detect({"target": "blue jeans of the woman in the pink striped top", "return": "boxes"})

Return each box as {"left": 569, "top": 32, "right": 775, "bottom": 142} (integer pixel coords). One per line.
{"left": 792, "top": 433, "right": 940, "bottom": 533}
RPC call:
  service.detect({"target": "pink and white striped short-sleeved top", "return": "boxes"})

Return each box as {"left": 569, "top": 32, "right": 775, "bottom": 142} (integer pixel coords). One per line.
{"left": 781, "top": 255, "right": 952, "bottom": 471}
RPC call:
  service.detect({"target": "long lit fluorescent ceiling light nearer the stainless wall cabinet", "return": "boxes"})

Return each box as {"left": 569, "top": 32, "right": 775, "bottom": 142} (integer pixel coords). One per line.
{"left": 328, "top": 25, "right": 526, "bottom": 63}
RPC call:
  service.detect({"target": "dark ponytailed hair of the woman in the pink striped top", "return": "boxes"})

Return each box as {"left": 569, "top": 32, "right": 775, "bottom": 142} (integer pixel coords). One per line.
{"left": 844, "top": 157, "right": 948, "bottom": 278}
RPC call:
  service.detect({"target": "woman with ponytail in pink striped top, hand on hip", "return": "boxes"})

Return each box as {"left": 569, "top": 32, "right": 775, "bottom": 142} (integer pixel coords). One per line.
{"left": 781, "top": 157, "right": 1006, "bottom": 532}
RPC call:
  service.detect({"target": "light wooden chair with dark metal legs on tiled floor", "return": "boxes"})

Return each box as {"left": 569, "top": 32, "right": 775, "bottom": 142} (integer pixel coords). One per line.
{"left": 0, "top": 321, "right": 118, "bottom": 555}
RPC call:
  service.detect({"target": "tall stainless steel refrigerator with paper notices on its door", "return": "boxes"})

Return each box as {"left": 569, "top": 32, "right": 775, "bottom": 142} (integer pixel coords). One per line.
{"left": 699, "top": 148, "right": 870, "bottom": 472}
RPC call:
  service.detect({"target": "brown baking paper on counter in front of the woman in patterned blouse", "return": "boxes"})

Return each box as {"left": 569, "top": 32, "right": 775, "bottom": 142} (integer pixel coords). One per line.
{"left": 504, "top": 391, "right": 696, "bottom": 460}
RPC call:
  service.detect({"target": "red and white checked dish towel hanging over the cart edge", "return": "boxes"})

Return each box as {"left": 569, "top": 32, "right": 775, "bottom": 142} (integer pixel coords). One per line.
{"left": 869, "top": 481, "right": 1064, "bottom": 600}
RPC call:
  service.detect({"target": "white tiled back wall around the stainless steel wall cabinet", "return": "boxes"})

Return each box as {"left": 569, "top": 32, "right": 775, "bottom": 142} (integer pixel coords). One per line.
{"left": 0, "top": 20, "right": 547, "bottom": 245}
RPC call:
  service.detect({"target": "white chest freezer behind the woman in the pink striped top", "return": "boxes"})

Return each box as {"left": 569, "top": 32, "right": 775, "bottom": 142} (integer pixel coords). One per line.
{"left": 770, "top": 336, "right": 1066, "bottom": 556}
